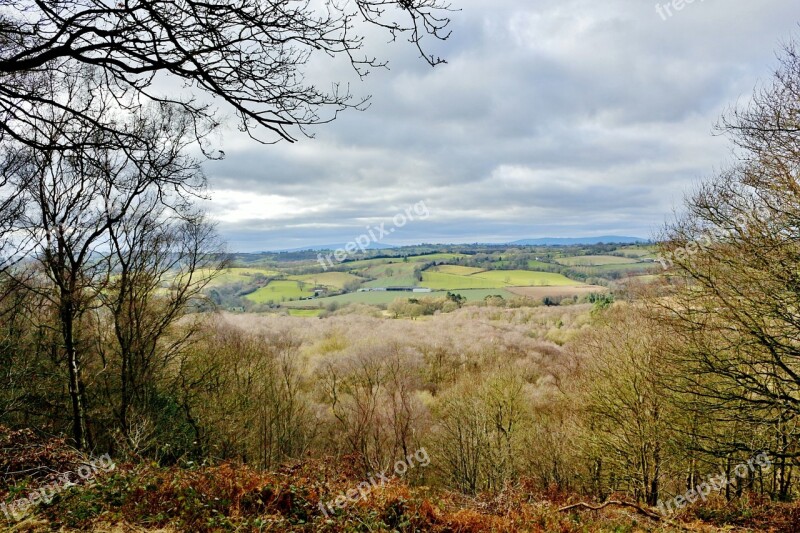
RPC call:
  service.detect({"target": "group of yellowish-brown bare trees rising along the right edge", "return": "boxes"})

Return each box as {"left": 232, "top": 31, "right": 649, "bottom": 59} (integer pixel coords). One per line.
{"left": 583, "top": 40, "right": 800, "bottom": 504}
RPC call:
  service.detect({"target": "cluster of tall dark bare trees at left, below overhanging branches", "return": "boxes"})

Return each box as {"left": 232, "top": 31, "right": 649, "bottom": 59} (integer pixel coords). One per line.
{"left": 0, "top": 69, "right": 224, "bottom": 450}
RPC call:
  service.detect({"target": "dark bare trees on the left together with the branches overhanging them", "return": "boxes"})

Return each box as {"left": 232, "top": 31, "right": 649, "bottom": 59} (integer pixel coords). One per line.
{"left": 0, "top": 0, "right": 449, "bottom": 457}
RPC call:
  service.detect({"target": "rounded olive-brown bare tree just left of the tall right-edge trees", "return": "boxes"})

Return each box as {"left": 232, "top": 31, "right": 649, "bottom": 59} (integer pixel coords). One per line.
{"left": 576, "top": 304, "right": 679, "bottom": 505}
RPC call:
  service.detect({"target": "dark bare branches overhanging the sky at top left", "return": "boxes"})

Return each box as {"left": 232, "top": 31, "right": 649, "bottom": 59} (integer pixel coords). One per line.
{"left": 0, "top": 0, "right": 450, "bottom": 148}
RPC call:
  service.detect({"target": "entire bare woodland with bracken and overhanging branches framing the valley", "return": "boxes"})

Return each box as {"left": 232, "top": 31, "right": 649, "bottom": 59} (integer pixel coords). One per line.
{"left": 0, "top": 0, "right": 800, "bottom": 531}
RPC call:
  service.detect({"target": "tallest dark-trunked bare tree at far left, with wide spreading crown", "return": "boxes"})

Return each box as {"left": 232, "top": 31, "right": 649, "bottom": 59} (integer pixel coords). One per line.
{"left": 0, "top": 67, "right": 209, "bottom": 448}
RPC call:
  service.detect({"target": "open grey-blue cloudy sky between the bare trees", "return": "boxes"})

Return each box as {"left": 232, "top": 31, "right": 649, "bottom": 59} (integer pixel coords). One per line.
{"left": 198, "top": 0, "right": 800, "bottom": 251}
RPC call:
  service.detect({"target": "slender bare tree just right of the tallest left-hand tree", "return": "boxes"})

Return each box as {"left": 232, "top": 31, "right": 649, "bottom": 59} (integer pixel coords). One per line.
{"left": 99, "top": 195, "right": 225, "bottom": 445}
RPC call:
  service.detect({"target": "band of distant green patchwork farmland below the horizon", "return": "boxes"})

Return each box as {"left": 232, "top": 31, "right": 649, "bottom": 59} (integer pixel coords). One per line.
{"left": 205, "top": 245, "right": 654, "bottom": 316}
